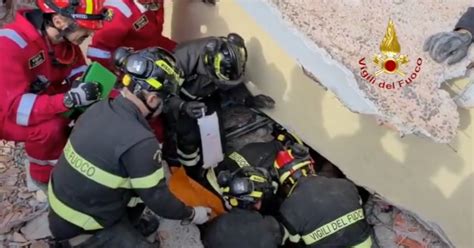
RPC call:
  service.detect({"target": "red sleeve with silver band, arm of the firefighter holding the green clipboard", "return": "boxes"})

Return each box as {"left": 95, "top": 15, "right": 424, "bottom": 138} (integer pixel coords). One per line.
{"left": 0, "top": 39, "right": 67, "bottom": 126}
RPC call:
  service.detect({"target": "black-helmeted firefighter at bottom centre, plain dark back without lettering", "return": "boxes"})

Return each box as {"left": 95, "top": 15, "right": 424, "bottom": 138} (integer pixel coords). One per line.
{"left": 203, "top": 166, "right": 283, "bottom": 248}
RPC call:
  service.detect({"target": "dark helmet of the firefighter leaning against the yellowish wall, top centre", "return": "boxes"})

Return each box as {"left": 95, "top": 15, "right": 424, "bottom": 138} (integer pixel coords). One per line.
{"left": 205, "top": 33, "right": 247, "bottom": 86}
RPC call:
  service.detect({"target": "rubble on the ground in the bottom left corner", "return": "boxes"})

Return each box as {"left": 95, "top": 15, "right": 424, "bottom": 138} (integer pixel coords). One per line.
{"left": 0, "top": 141, "right": 49, "bottom": 248}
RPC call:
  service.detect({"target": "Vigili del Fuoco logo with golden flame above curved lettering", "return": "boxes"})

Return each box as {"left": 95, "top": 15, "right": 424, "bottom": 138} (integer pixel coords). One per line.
{"left": 359, "top": 20, "right": 423, "bottom": 90}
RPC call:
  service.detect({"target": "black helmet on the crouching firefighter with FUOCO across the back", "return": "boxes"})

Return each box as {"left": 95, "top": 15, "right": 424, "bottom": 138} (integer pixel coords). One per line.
{"left": 114, "top": 47, "right": 183, "bottom": 95}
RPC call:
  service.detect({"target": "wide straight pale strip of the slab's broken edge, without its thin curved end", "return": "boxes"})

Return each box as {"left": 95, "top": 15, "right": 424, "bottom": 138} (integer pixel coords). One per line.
{"left": 236, "top": 0, "right": 380, "bottom": 115}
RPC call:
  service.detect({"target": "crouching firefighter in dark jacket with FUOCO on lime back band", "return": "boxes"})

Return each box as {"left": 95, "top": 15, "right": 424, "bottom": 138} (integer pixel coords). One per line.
{"left": 48, "top": 48, "right": 210, "bottom": 247}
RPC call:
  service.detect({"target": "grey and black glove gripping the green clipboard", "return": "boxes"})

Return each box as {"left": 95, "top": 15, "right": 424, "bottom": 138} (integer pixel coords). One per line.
{"left": 64, "top": 81, "right": 100, "bottom": 108}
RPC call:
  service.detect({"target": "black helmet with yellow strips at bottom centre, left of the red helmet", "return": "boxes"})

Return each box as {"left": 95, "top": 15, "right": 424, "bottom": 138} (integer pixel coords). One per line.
{"left": 217, "top": 166, "right": 273, "bottom": 208}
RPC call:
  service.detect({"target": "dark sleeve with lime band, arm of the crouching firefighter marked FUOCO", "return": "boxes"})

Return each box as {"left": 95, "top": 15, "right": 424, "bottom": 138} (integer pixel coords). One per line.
{"left": 121, "top": 138, "right": 193, "bottom": 220}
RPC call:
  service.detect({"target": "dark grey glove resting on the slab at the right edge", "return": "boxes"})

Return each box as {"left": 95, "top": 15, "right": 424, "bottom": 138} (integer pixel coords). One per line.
{"left": 423, "top": 31, "right": 472, "bottom": 65}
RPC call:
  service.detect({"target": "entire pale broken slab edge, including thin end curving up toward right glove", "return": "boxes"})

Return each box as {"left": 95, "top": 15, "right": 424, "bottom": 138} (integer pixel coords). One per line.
{"left": 236, "top": 0, "right": 467, "bottom": 144}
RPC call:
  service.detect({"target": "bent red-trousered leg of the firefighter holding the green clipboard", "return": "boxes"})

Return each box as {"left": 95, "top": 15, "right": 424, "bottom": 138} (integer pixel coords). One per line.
{"left": 3, "top": 117, "right": 70, "bottom": 183}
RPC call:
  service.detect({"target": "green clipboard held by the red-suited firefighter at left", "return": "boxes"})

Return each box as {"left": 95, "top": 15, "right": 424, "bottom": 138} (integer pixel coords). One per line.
{"left": 64, "top": 62, "right": 117, "bottom": 117}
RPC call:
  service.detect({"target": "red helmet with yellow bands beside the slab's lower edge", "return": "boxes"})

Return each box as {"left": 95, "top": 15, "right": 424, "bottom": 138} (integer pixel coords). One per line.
{"left": 274, "top": 143, "right": 314, "bottom": 185}
